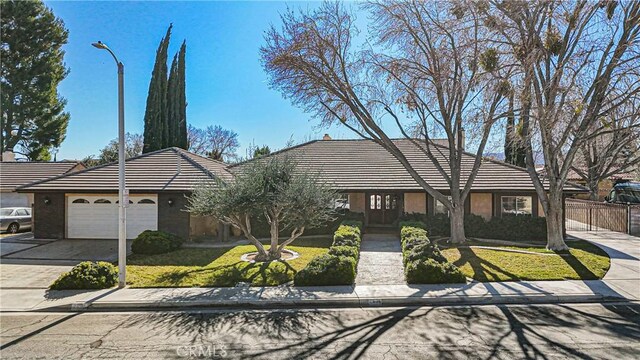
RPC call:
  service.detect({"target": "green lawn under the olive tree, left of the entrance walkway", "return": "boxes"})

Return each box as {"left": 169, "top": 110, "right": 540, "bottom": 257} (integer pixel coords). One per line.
{"left": 127, "top": 238, "right": 332, "bottom": 287}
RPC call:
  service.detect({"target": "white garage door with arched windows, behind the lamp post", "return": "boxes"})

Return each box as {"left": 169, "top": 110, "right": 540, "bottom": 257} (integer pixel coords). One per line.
{"left": 67, "top": 195, "right": 158, "bottom": 239}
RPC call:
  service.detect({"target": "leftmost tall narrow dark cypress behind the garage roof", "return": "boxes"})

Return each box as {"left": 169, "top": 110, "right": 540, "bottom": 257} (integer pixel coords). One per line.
{"left": 142, "top": 24, "right": 173, "bottom": 153}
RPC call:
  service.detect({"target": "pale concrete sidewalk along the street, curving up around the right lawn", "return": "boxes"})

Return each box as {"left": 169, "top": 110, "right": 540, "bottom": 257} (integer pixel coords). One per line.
{"left": 0, "top": 232, "right": 640, "bottom": 311}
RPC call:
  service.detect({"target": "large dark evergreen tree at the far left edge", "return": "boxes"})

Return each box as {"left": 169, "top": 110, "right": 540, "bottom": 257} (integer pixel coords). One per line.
{"left": 0, "top": 0, "right": 69, "bottom": 160}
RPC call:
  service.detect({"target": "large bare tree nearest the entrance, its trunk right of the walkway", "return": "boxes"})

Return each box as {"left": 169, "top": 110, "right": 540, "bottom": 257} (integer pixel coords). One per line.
{"left": 261, "top": 1, "right": 505, "bottom": 242}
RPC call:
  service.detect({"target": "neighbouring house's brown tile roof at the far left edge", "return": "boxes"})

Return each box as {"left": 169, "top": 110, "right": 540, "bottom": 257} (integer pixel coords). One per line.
{"left": 0, "top": 161, "right": 85, "bottom": 192}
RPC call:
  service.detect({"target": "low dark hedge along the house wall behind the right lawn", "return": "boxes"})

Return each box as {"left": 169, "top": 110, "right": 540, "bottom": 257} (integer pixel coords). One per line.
{"left": 401, "top": 213, "right": 547, "bottom": 241}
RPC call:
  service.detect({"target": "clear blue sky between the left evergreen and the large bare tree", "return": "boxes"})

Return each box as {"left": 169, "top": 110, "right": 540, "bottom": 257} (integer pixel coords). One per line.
{"left": 45, "top": 1, "right": 360, "bottom": 159}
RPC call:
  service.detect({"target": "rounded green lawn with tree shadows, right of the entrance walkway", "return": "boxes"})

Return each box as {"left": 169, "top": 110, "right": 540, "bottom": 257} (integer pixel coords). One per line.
{"left": 442, "top": 241, "right": 611, "bottom": 282}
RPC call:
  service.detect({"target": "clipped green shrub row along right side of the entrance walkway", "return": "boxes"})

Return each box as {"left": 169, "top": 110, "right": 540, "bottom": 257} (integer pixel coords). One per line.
{"left": 400, "top": 221, "right": 467, "bottom": 284}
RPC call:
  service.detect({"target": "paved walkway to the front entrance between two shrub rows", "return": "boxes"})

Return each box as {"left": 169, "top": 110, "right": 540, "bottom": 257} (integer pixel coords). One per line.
{"left": 356, "top": 234, "right": 406, "bottom": 285}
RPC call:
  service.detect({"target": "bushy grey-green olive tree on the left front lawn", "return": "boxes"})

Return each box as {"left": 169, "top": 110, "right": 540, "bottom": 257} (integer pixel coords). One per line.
{"left": 188, "top": 156, "right": 337, "bottom": 261}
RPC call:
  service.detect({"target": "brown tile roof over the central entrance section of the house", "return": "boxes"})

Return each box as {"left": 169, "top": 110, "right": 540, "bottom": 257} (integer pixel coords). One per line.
{"left": 229, "top": 139, "right": 584, "bottom": 191}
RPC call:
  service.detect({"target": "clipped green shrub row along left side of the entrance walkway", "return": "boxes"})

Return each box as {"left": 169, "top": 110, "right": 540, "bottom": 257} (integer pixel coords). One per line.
{"left": 293, "top": 220, "right": 362, "bottom": 286}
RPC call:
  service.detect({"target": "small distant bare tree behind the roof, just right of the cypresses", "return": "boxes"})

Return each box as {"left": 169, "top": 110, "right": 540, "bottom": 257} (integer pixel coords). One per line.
{"left": 187, "top": 125, "right": 240, "bottom": 161}
